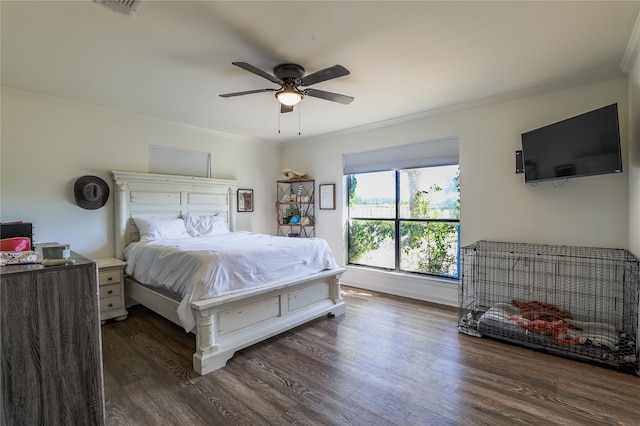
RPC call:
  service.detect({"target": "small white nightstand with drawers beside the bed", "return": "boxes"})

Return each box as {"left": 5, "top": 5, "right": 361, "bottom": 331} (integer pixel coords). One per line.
{"left": 96, "top": 257, "right": 128, "bottom": 324}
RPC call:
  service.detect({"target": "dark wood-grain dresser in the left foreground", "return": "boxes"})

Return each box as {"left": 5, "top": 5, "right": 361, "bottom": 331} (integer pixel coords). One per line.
{"left": 0, "top": 252, "right": 106, "bottom": 425}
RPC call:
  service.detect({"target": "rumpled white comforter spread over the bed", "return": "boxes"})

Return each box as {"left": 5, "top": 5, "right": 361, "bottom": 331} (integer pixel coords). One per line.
{"left": 124, "top": 231, "right": 338, "bottom": 331}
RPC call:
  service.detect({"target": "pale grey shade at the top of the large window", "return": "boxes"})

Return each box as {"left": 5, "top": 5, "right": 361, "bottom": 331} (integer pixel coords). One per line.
{"left": 342, "top": 137, "right": 459, "bottom": 175}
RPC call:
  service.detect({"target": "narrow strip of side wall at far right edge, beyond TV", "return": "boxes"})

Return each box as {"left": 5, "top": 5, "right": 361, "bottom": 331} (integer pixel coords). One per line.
{"left": 628, "top": 56, "right": 640, "bottom": 256}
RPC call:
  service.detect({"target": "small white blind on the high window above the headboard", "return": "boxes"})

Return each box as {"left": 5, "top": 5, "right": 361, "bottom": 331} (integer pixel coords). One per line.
{"left": 149, "top": 145, "right": 211, "bottom": 178}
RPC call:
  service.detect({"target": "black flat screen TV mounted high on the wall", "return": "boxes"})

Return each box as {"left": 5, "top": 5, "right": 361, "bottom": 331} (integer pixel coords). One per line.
{"left": 522, "top": 104, "right": 622, "bottom": 183}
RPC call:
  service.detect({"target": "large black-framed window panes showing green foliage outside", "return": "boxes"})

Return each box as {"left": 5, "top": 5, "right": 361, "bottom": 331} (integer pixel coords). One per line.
{"left": 348, "top": 164, "right": 460, "bottom": 278}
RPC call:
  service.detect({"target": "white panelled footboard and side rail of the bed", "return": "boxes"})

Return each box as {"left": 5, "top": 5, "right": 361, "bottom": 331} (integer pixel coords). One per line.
{"left": 126, "top": 268, "right": 345, "bottom": 374}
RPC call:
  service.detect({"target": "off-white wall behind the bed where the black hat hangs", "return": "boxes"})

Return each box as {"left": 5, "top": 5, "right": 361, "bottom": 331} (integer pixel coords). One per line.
{"left": 0, "top": 87, "right": 281, "bottom": 258}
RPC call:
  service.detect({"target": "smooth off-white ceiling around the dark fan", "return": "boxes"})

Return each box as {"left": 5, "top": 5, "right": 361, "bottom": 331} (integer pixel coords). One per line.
{"left": 0, "top": 0, "right": 640, "bottom": 142}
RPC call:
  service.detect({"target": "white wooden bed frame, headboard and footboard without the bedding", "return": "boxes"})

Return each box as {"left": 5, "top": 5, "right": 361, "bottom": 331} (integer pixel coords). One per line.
{"left": 112, "top": 171, "right": 345, "bottom": 374}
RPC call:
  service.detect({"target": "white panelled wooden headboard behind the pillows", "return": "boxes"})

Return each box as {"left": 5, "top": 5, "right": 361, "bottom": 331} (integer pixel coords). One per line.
{"left": 111, "top": 171, "right": 239, "bottom": 259}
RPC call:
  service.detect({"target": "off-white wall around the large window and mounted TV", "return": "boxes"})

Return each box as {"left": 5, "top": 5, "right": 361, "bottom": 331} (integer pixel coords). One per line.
{"left": 282, "top": 77, "right": 629, "bottom": 305}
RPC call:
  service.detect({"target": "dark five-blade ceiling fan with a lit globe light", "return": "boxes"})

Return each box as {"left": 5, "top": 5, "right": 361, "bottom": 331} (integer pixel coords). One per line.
{"left": 220, "top": 62, "right": 353, "bottom": 113}
